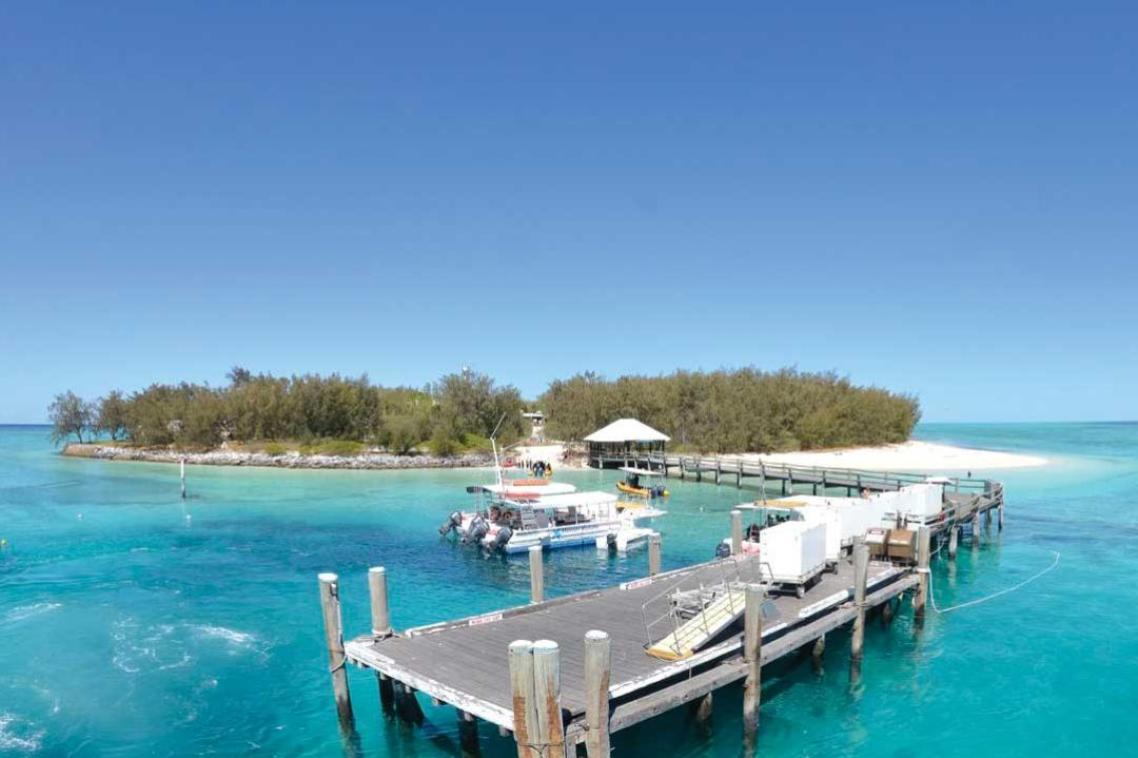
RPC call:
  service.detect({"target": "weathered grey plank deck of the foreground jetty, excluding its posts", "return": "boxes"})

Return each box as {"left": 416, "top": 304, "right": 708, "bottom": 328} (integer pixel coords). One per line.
{"left": 336, "top": 558, "right": 916, "bottom": 739}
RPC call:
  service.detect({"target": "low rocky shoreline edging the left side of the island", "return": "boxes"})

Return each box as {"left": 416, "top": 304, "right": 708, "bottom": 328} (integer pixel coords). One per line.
{"left": 63, "top": 443, "right": 494, "bottom": 470}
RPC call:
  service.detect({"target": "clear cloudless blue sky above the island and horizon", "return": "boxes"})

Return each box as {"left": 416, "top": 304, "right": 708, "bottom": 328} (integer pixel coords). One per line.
{"left": 0, "top": 1, "right": 1138, "bottom": 422}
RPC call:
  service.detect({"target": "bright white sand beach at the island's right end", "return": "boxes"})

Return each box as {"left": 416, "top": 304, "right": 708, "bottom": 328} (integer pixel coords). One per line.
{"left": 728, "top": 439, "right": 1047, "bottom": 471}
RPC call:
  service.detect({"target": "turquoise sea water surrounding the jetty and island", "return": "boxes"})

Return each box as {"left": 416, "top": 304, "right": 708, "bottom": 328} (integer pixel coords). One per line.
{"left": 0, "top": 423, "right": 1138, "bottom": 757}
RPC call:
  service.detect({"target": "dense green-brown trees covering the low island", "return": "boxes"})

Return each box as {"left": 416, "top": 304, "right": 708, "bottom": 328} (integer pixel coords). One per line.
{"left": 50, "top": 366, "right": 921, "bottom": 455}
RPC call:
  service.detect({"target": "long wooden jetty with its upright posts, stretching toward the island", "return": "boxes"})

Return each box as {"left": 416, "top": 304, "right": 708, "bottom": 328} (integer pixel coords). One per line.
{"left": 320, "top": 456, "right": 1004, "bottom": 758}
